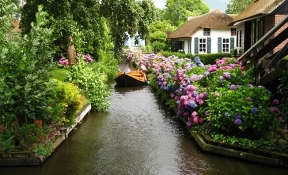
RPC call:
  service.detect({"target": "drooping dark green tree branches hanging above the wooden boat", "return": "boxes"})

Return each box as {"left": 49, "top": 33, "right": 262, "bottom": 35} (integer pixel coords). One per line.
{"left": 101, "top": 0, "right": 156, "bottom": 57}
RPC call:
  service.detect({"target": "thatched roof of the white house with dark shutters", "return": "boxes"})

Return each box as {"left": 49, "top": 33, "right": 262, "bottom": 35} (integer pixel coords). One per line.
{"left": 168, "top": 10, "right": 233, "bottom": 38}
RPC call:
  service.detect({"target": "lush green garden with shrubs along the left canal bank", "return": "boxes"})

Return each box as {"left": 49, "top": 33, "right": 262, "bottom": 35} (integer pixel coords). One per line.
{"left": 0, "top": 4, "right": 118, "bottom": 158}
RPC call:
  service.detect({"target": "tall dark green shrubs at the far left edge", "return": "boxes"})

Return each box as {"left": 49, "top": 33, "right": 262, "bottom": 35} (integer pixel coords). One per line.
{"left": 0, "top": 3, "right": 71, "bottom": 154}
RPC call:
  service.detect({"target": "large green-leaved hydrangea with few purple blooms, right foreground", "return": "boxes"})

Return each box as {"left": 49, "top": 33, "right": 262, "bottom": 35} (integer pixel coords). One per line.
{"left": 206, "top": 86, "right": 279, "bottom": 134}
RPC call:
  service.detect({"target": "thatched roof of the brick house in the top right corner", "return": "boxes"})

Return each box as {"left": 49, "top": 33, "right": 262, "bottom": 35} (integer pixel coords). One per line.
{"left": 229, "top": 0, "right": 286, "bottom": 25}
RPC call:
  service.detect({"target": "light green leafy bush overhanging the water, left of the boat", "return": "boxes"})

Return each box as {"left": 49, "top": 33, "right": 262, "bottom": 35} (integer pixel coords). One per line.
{"left": 68, "top": 57, "right": 111, "bottom": 111}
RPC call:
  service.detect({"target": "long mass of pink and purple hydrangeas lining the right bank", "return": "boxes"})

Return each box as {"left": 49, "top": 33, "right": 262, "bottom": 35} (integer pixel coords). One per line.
{"left": 127, "top": 51, "right": 280, "bottom": 135}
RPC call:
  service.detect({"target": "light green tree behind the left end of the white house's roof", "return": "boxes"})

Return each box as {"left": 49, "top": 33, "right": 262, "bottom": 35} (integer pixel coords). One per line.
{"left": 164, "top": 0, "right": 210, "bottom": 26}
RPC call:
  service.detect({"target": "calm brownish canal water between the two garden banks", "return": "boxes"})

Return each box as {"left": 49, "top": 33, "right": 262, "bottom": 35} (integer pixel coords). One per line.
{"left": 0, "top": 84, "right": 288, "bottom": 175}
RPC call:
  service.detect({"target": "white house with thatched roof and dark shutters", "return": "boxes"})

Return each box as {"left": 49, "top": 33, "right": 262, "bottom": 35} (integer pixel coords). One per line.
{"left": 168, "top": 10, "right": 236, "bottom": 54}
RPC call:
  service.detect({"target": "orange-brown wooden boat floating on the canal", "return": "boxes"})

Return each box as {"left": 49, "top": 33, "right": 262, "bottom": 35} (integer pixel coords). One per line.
{"left": 115, "top": 71, "right": 147, "bottom": 87}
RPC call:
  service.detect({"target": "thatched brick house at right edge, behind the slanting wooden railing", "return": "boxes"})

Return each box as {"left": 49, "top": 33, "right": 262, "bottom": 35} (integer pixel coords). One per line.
{"left": 229, "top": 0, "right": 288, "bottom": 54}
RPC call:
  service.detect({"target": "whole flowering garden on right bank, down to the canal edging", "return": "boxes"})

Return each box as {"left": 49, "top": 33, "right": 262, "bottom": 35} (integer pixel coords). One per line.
{"left": 127, "top": 50, "right": 288, "bottom": 154}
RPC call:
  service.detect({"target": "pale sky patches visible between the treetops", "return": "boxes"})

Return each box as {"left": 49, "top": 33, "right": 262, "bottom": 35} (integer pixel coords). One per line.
{"left": 153, "top": 0, "right": 230, "bottom": 12}
